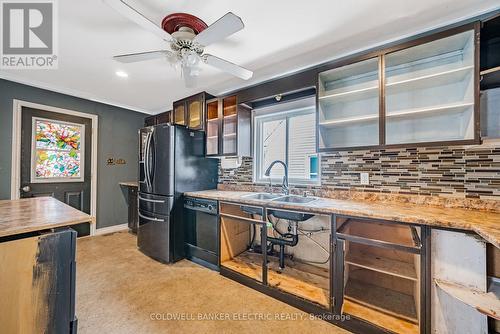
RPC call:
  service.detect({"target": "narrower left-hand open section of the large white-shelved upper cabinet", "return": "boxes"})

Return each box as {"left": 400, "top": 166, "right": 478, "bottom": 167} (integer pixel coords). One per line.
{"left": 318, "top": 57, "right": 380, "bottom": 150}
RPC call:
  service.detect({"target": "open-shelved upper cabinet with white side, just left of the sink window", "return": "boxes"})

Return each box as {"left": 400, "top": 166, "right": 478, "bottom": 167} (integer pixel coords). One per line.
{"left": 206, "top": 96, "right": 251, "bottom": 156}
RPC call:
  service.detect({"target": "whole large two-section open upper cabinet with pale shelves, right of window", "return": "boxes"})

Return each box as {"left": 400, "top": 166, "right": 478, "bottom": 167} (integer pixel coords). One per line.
{"left": 317, "top": 24, "right": 480, "bottom": 151}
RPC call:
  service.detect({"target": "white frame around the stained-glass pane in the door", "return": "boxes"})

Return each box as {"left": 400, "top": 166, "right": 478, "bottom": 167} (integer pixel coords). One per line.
{"left": 30, "top": 117, "right": 85, "bottom": 183}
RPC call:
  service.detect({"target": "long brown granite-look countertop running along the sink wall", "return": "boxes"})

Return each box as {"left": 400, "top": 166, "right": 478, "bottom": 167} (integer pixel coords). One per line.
{"left": 184, "top": 190, "right": 500, "bottom": 248}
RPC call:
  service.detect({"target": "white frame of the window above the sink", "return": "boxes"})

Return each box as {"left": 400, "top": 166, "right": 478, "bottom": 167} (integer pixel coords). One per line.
{"left": 252, "top": 98, "right": 321, "bottom": 186}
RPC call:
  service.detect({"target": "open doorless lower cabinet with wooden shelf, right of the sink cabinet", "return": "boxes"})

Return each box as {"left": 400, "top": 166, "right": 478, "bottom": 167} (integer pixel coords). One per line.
{"left": 333, "top": 215, "right": 428, "bottom": 333}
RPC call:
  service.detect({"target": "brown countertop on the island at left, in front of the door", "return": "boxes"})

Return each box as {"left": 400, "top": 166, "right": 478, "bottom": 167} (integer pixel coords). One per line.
{"left": 0, "top": 197, "right": 92, "bottom": 237}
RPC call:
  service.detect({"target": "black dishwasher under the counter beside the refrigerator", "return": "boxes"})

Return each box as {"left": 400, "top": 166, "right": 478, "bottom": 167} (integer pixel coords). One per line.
{"left": 184, "top": 197, "right": 219, "bottom": 270}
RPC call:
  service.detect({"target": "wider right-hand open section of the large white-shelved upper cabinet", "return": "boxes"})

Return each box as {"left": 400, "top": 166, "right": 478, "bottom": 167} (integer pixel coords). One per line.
{"left": 385, "top": 30, "right": 476, "bottom": 145}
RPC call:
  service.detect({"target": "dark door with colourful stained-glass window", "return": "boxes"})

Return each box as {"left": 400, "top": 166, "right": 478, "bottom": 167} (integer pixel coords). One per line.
{"left": 20, "top": 107, "right": 92, "bottom": 220}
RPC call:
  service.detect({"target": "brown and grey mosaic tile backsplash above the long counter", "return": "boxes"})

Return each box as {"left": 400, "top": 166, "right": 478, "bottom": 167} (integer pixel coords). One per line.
{"left": 219, "top": 143, "right": 500, "bottom": 200}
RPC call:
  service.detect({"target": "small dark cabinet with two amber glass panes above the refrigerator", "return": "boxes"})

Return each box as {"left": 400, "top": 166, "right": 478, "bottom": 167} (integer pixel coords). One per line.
{"left": 174, "top": 92, "right": 213, "bottom": 130}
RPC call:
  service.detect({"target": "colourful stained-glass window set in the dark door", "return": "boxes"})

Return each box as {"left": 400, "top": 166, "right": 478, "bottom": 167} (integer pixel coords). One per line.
{"left": 31, "top": 117, "right": 85, "bottom": 183}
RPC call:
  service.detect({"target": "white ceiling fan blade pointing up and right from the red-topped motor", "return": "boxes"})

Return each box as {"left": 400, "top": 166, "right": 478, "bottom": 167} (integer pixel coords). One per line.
{"left": 193, "top": 12, "right": 245, "bottom": 46}
